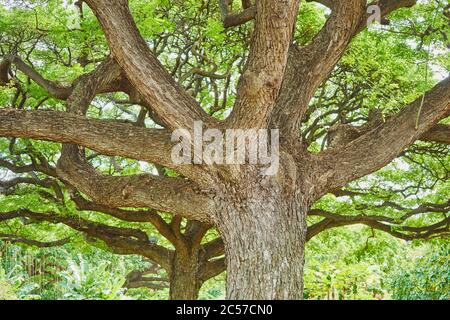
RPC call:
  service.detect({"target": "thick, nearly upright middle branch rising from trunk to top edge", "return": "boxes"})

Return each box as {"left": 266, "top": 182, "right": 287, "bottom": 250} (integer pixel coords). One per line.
{"left": 229, "top": 0, "right": 299, "bottom": 128}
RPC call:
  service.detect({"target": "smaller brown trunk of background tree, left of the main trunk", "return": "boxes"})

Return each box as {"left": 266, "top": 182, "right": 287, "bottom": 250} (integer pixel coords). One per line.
{"left": 169, "top": 250, "right": 203, "bottom": 300}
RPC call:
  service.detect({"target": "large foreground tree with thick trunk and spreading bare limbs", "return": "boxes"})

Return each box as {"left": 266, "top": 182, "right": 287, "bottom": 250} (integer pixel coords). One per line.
{"left": 0, "top": 0, "right": 450, "bottom": 299}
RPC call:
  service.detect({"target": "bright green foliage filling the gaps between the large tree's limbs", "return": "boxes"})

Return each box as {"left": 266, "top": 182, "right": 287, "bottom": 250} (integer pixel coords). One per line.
{"left": 0, "top": 0, "right": 450, "bottom": 299}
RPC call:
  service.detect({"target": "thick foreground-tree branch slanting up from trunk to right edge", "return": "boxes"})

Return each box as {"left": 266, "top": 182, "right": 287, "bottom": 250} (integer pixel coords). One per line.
{"left": 311, "top": 77, "right": 450, "bottom": 194}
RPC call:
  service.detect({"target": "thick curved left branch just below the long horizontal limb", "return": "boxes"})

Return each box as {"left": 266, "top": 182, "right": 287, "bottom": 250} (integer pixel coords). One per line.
{"left": 57, "top": 145, "right": 212, "bottom": 221}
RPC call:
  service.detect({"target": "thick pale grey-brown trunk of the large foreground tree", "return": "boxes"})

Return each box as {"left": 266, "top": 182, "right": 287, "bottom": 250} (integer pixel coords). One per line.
{"left": 219, "top": 182, "right": 307, "bottom": 300}
